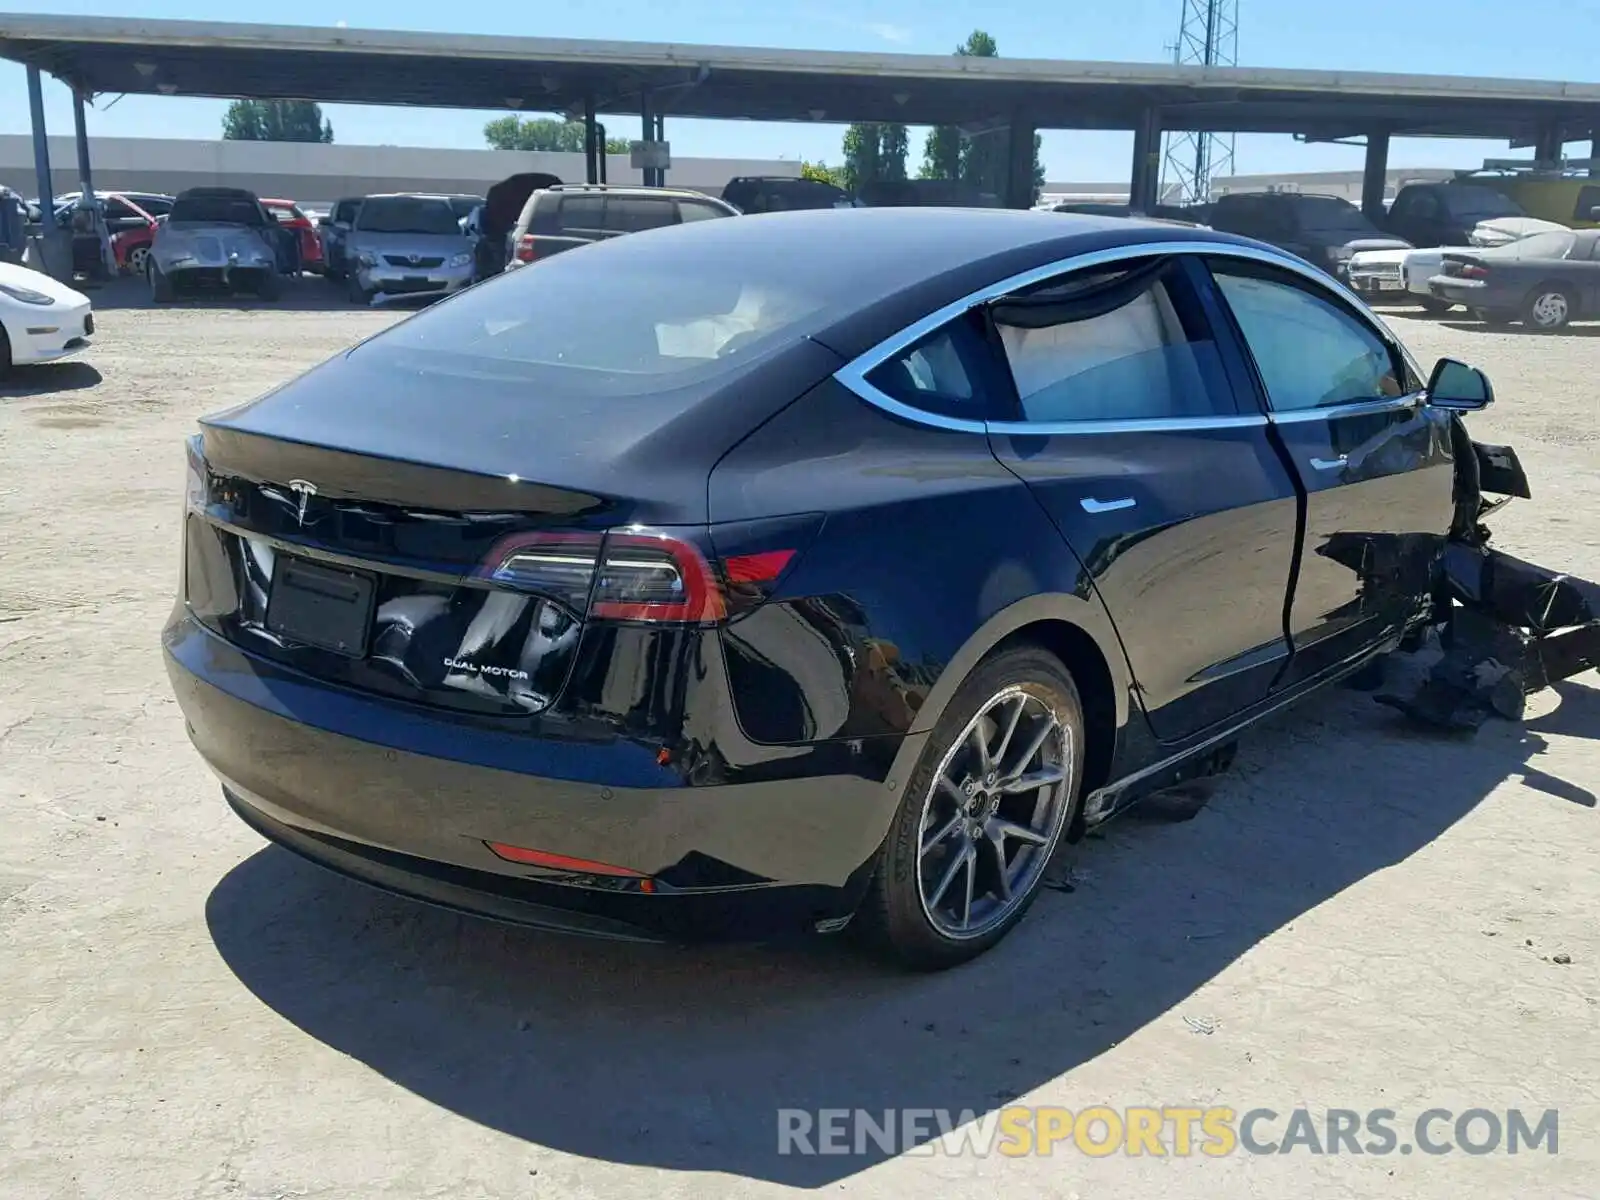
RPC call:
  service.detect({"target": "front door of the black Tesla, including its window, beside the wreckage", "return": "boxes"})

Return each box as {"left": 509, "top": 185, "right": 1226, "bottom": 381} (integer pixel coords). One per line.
{"left": 1208, "top": 256, "right": 1454, "bottom": 683}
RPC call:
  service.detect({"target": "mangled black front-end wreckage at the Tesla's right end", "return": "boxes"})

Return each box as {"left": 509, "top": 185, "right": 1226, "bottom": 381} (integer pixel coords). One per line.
{"left": 1376, "top": 432, "right": 1600, "bottom": 730}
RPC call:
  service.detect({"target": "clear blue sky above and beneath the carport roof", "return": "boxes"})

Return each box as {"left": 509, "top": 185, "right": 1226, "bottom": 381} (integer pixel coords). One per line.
{"left": 0, "top": 0, "right": 1600, "bottom": 181}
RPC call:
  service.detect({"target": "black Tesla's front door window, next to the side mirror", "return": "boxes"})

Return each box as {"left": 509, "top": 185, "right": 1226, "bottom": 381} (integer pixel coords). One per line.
{"left": 1210, "top": 259, "right": 1408, "bottom": 413}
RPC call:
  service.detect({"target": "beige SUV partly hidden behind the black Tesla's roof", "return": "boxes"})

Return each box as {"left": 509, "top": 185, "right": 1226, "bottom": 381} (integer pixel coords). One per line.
{"left": 510, "top": 184, "right": 739, "bottom": 266}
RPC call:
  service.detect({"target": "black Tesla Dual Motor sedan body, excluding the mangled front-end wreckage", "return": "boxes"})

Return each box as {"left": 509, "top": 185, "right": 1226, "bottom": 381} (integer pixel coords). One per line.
{"left": 165, "top": 210, "right": 1490, "bottom": 966}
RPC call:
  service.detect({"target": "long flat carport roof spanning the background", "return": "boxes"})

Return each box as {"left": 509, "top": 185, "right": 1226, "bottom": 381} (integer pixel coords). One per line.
{"left": 9, "top": 14, "right": 1600, "bottom": 141}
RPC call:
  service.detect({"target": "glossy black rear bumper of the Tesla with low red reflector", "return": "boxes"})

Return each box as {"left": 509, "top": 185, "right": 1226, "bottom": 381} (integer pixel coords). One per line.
{"left": 163, "top": 614, "right": 894, "bottom": 941}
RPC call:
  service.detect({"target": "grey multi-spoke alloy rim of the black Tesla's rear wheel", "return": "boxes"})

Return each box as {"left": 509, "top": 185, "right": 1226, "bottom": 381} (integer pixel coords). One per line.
{"left": 917, "top": 683, "right": 1075, "bottom": 941}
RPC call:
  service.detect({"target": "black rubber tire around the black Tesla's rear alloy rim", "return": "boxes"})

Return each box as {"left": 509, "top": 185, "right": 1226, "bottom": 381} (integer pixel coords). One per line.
{"left": 856, "top": 645, "right": 1083, "bottom": 971}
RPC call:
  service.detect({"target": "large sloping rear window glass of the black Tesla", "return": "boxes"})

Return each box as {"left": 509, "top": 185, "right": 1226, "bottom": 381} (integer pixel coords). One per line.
{"left": 352, "top": 230, "right": 859, "bottom": 402}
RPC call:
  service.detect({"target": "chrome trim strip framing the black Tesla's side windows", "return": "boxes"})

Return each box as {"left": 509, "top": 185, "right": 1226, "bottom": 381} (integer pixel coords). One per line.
{"left": 834, "top": 242, "right": 1414, "bottom": 437}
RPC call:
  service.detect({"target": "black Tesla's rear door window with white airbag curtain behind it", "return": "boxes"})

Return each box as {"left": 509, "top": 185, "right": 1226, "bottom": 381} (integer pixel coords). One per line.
{"left": 992, "top": 259, "right": 1235, "bottom": 424}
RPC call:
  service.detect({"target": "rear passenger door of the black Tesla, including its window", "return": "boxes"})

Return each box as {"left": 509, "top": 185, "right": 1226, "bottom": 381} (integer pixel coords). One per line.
{"left": 989, "top": 253, "right": 1298, "bottom": 741}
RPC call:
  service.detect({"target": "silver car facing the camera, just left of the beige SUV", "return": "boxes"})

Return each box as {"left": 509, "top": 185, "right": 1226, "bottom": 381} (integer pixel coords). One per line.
{"left": 344, "top": 194, "right": 477, "bottom": 304}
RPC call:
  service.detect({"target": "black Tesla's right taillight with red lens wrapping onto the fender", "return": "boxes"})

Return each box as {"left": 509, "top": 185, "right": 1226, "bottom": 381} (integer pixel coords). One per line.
{"left": 480, "top": 518, "right": 816, "bottom": 626}
